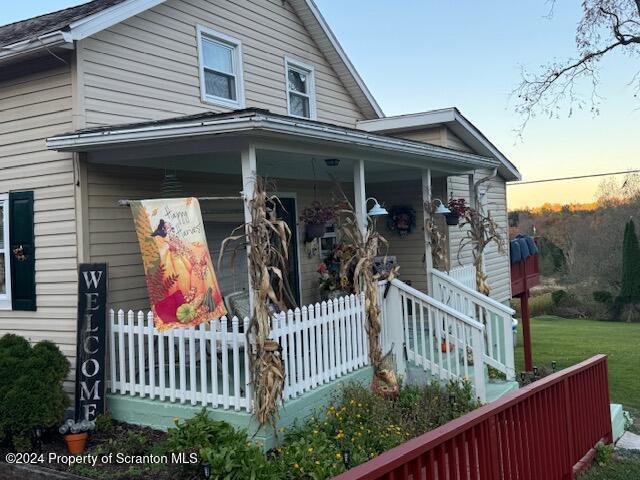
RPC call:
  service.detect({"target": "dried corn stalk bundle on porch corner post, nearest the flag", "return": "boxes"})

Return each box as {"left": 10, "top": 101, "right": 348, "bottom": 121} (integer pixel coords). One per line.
{"left": 218, "top": 177, "right": 294, "bottom": 427}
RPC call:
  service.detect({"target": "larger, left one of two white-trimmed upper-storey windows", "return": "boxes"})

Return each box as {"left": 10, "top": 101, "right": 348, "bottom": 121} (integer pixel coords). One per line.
{"left": 198, "top": 26, "right": 244, "bottom": 108}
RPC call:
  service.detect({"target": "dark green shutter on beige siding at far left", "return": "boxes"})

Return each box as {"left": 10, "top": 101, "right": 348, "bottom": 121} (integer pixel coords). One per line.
{"left": 9, "top": 192, "right": 36, "bottom": 310}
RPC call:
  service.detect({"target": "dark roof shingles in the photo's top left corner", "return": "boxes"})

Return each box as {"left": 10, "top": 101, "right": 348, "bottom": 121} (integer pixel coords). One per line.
{"left": 0, "top": 0, "right": 125, "bottom": 46}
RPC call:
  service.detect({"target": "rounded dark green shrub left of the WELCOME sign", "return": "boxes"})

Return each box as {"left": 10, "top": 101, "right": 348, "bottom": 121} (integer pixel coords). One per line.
{"left": 0, "top": 335, "right": 70, "bottom": 451}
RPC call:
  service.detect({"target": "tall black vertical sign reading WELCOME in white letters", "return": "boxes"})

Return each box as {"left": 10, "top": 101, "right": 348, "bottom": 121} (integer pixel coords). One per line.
{"left": 75, "top": 263, "right": 108, "bottom": 421}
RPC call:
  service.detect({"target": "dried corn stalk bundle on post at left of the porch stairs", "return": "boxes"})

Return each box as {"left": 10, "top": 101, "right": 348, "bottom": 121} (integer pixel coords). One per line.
{"left": 337, "top": 185, "right": 397, "bottom": 388}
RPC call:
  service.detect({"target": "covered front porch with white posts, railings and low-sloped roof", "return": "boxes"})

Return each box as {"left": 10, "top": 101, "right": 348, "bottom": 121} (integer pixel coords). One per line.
{"left": 48, "top": 110, "right": 513, "bottom": 438}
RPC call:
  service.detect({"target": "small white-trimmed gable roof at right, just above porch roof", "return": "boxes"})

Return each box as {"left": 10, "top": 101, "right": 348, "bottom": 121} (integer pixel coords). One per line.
{"left": 357, "top": 107, "right": 522, "bottom": 181}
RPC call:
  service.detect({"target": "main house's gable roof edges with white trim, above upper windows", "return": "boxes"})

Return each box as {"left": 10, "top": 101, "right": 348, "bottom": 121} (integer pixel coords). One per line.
{"left": 0, "top": 0, "right": 384, "bottom": 118}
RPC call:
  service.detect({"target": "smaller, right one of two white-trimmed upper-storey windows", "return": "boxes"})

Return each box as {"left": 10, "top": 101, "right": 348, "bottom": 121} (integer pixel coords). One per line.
{"left": 285, "top": 58, "right": 316, "bottom": 118}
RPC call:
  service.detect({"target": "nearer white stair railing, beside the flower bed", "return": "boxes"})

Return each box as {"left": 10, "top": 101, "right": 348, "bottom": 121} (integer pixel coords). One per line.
{"left": 380, "top": 280, "right": 486, "bottom": 401}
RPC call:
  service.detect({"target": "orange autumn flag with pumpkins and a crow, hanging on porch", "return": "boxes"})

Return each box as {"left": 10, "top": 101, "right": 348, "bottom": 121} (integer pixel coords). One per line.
{"left": 131, "top": 197, "right": 227, "bottom": 330}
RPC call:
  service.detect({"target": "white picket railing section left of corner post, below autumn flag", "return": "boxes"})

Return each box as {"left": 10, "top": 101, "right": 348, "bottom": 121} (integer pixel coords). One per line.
{"left": 109, "top": 310, "right": 251, "bottom": 411}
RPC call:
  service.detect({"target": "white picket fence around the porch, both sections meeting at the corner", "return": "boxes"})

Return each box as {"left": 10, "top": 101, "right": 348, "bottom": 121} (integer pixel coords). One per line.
{"left": 109, "top": 295, "right": 369, "bottom": 412}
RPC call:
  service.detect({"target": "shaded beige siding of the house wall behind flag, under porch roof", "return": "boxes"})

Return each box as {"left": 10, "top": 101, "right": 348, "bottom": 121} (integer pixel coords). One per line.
{"left": 87, "top": 164, "right": 350, "bottom": 310}
